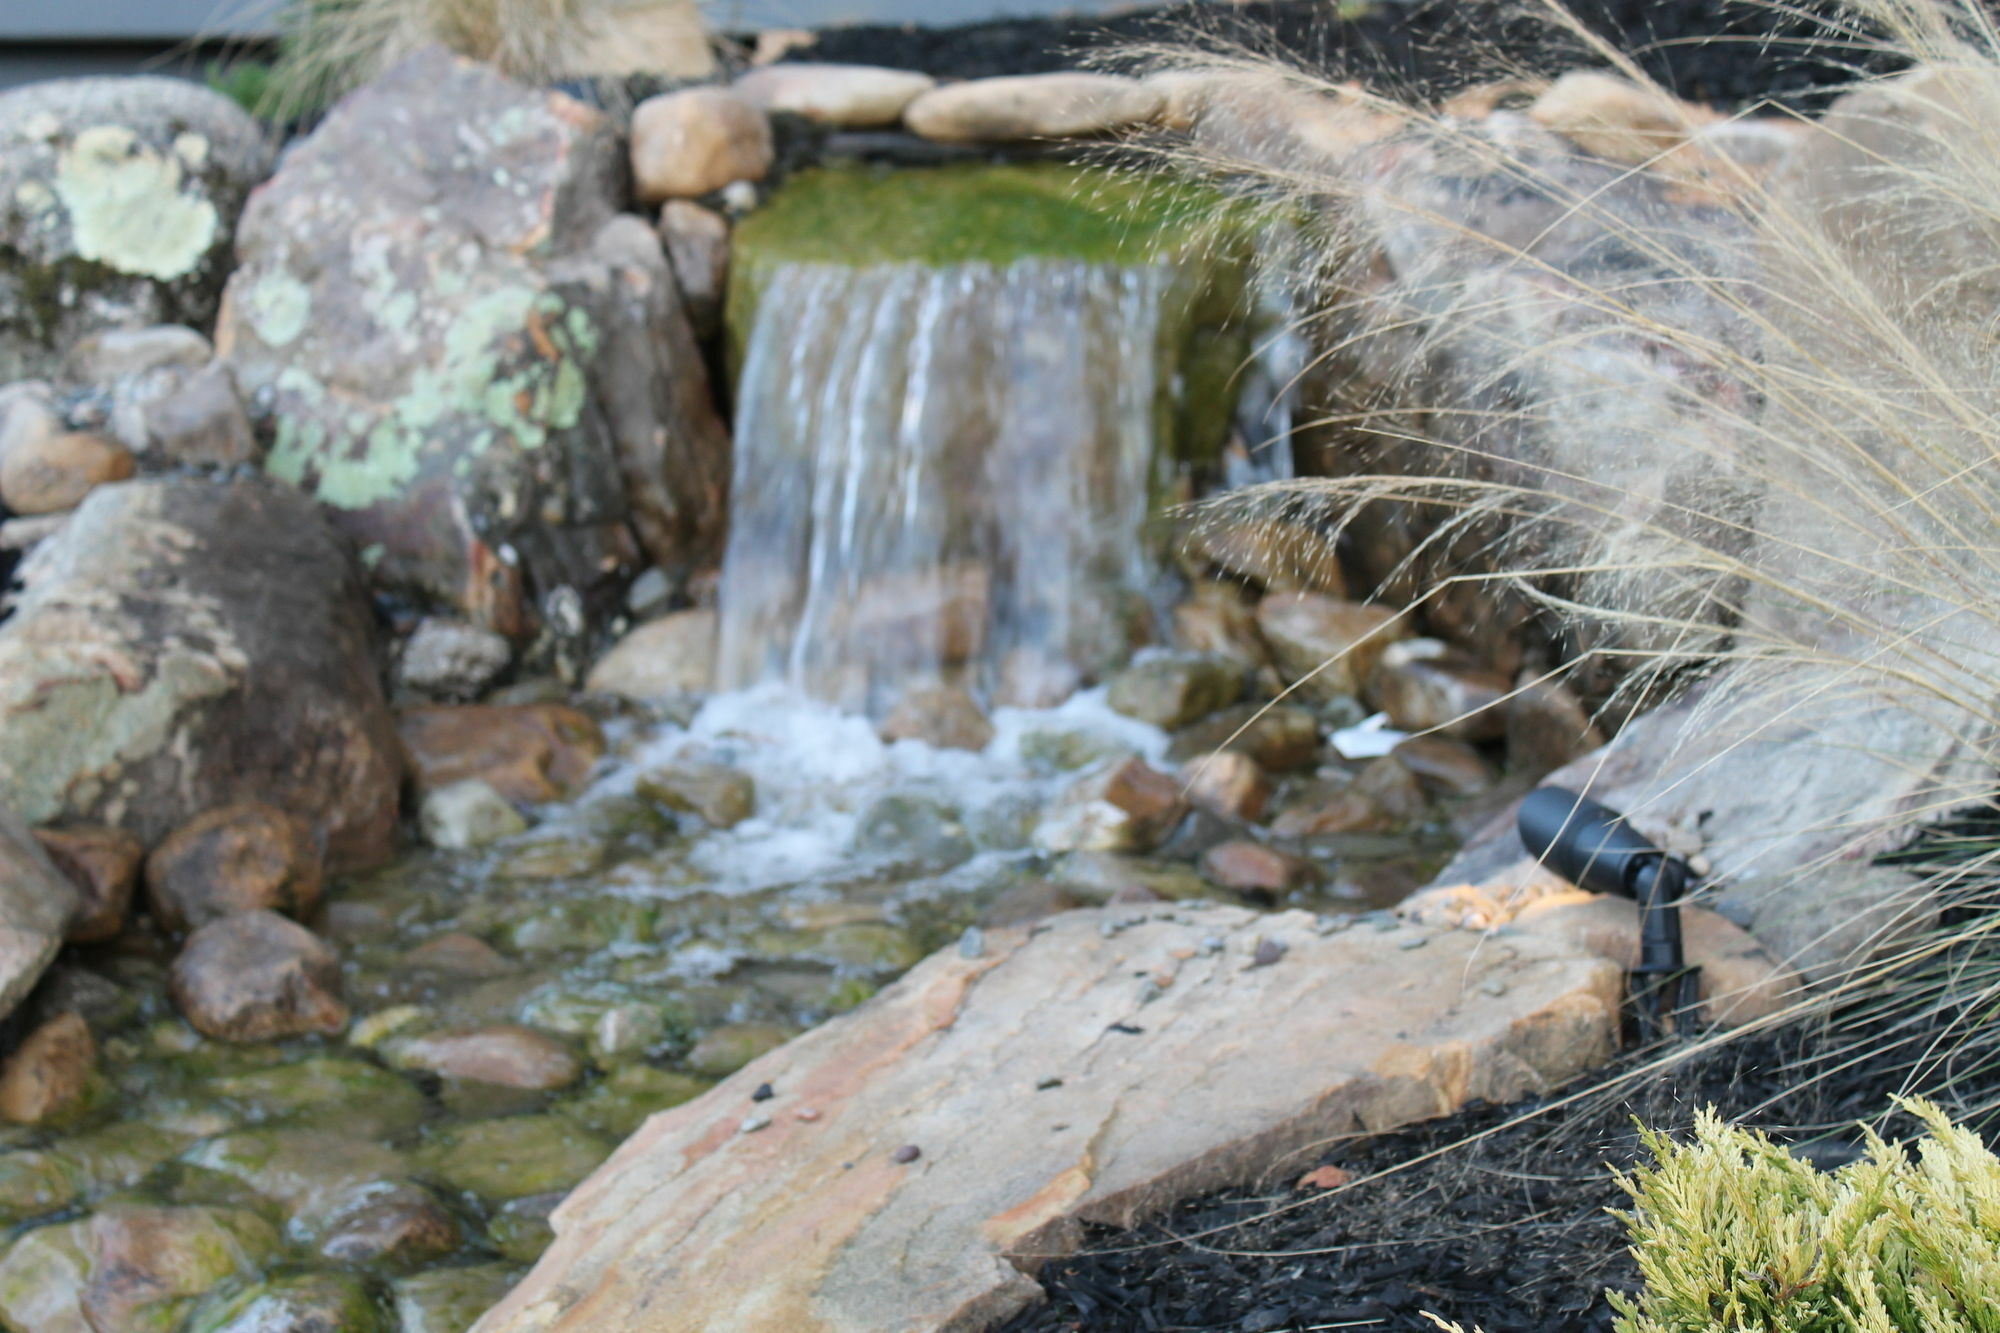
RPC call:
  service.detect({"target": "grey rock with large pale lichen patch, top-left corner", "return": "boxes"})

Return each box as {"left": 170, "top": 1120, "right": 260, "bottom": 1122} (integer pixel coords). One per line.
{"left": 0, "top": 78, "right": 272, "bottom": 382}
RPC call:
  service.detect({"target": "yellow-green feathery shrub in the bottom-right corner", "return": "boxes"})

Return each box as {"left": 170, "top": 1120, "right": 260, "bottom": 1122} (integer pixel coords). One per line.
{"left": 1610, "top": 1099, "right": 2000, "bottom": 1333}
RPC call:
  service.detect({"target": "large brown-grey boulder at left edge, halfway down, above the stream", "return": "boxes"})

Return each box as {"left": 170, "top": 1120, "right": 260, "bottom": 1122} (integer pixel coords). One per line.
{"left": 0, "top": 478, "right": 402, "bottom": 869}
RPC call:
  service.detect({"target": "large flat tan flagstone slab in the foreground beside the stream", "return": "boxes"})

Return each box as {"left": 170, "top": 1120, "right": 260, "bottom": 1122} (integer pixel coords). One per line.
{"left": 476, "top": 905, "right": 1622, "bottom": 1333}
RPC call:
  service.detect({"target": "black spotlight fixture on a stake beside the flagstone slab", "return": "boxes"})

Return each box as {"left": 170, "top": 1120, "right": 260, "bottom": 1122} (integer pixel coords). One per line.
{"left": 1520, "top": 787, "right": 1700, "bottom": 1041}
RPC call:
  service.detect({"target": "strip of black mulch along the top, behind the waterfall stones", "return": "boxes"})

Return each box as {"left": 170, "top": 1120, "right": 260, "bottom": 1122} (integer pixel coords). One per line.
{"left": 790, "top": 0, "right": 1920, "bottom": 106}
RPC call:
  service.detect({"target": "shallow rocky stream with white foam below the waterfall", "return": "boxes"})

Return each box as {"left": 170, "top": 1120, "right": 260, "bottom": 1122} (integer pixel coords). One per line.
{"left": 0, "top": 691, "right": 1450, "bottom": 1333}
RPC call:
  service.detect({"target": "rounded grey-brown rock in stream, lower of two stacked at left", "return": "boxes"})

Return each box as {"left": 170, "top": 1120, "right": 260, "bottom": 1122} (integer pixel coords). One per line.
{"left": 172, "top": 911, "right": 348, "bottom": 1041}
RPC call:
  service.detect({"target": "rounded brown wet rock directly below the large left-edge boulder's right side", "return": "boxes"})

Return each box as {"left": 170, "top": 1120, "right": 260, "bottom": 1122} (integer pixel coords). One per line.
{"left": 146, "top": 801, "right": 322, "bottom": 935}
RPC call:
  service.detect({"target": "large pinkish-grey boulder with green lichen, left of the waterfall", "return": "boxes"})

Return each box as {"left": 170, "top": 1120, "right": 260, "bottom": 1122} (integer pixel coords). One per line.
{"left": 216, "top": 50, "right": 728, "bottom": 634}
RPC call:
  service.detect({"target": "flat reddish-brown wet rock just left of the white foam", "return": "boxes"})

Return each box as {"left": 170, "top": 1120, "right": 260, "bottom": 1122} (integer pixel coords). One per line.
{"left": 396, "top": 705, "right": 604, "bottom": 805}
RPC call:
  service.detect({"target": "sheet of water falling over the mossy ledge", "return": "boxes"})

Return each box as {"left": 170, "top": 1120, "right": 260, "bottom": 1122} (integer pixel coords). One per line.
{"left": 720, "top": 258, "right": 1174, "bottom": 709}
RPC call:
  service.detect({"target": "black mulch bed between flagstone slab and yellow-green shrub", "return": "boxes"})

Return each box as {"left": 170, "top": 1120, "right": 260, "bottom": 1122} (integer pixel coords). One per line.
{"left": 1006, "top": 944, "right": 2000, "bottom": 1333}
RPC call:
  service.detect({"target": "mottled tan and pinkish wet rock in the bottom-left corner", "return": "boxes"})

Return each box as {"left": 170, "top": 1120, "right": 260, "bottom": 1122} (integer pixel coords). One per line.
{"left": 0, "top": 1203, "right": 278, "bottom": 1333}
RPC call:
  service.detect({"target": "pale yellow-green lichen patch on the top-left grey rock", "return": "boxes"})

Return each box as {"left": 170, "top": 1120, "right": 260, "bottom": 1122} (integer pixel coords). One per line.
{"left": 54, "top": 124, "right": 220, "bottom": 280}
